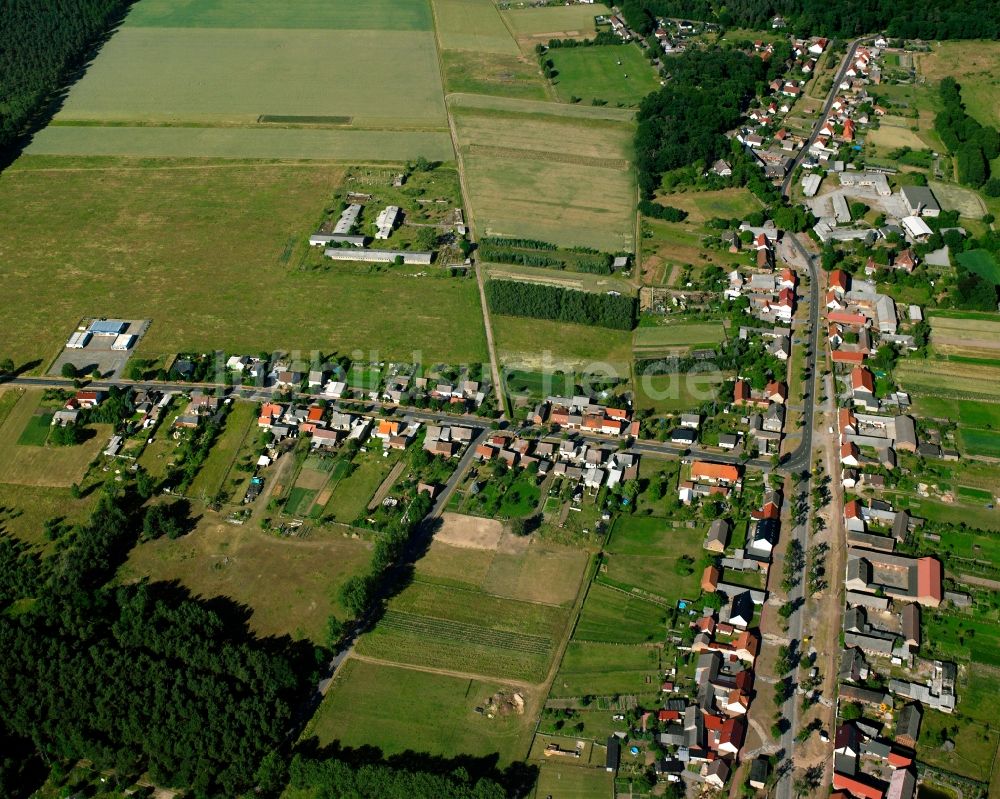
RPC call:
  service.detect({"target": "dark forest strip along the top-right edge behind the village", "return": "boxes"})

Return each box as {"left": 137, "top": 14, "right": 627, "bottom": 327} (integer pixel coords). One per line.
{"left": 618, "top": 0, "right": 1000, "bottom": 39}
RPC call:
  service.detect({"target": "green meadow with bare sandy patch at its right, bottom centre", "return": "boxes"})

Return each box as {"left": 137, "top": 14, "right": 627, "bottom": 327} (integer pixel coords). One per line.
{"left": 305, "top": 660, "right": 537, "bottom": 764}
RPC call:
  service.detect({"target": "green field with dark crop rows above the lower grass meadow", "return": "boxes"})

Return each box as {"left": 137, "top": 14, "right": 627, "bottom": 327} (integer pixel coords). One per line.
{"left": 357, "top": 582, "right": 568, "bottom": 683}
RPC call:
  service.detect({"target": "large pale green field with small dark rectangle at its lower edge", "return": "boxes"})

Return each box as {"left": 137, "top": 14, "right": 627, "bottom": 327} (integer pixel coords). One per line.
{"left": 56, "top": 27, "right": 445, "bottom": 127}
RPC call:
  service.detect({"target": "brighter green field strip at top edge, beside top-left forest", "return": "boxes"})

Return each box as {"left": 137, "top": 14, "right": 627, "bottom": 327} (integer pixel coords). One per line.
{"left": 125, "top": 0, "right": 432, "bottom": 31}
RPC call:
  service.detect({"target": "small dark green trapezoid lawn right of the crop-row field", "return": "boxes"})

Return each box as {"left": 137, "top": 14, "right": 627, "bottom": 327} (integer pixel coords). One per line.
{"left": 573, "top": 583, "right": 667, "bottom": 644}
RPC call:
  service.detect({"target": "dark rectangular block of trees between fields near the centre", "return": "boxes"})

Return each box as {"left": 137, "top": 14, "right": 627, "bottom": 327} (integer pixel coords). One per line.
{"left": 486, "top": 280, "right": 637, "bottom": 330}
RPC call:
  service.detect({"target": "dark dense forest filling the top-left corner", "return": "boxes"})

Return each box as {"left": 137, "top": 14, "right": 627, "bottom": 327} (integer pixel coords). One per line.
{"left": 0, "top": 0, "right": 133, "bottom": 152}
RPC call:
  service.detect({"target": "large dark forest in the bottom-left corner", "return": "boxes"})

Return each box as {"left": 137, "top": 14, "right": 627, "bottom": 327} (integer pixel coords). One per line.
{"left": 0, "top": 482, "right": 325, "bottom": 796}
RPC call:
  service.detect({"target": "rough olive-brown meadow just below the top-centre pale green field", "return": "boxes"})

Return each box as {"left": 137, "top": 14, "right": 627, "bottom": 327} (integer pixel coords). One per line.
{"left": 441, "top": 50, "right": 547, "bottom": 101}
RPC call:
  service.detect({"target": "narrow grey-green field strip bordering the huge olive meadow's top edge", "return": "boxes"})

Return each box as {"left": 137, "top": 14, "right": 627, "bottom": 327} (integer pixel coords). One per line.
{"left": 27, "top": 125, "right": 455, "bottom": 161}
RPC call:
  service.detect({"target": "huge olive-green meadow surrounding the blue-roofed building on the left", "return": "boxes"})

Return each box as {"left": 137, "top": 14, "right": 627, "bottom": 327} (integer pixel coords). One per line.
{"left": 0, "top": 157, "right": 485, "bottom": 363}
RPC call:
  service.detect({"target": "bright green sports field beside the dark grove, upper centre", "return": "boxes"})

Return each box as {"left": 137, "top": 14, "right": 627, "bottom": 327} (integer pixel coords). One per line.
{"left": 548, "top": 44, "right": 660, "bottom": 106}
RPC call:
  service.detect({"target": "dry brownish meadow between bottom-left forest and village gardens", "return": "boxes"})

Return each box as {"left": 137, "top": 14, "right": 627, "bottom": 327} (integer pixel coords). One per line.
{"left": 118, "top": 510, "right": 371, "bottom": 644}
